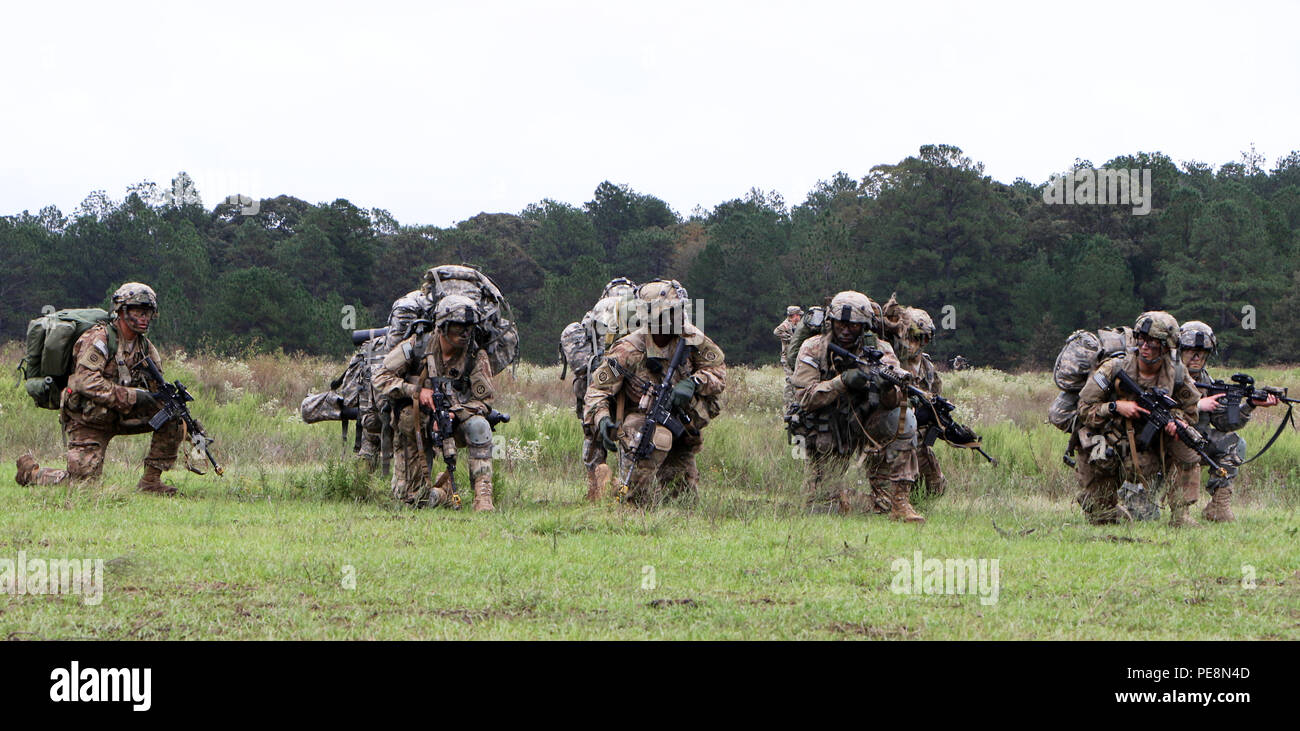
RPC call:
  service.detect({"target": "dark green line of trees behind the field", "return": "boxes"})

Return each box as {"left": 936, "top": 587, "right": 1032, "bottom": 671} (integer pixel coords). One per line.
{"left": 0, "top": 144, "right": 1300, "bottom": 368}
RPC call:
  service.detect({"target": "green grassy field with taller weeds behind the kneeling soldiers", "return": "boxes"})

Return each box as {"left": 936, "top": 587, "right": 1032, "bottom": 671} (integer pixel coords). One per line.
{"left": 0, "top": 343, "right": 1300, "bottom": 640}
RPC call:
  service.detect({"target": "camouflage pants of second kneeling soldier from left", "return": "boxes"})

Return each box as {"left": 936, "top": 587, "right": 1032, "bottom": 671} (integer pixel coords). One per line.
{"left": 393, "top": 406, "right": 491, "bottom": 505}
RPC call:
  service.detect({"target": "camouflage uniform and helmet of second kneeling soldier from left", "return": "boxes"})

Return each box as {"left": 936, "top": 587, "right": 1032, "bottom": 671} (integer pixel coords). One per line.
{"left": 373, "top": 295, "right": 497, "bottom": 510}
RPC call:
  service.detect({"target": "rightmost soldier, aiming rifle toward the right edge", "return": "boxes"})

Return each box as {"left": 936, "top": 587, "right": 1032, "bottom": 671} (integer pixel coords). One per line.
{"left": 1178, "top": 320, "right": 1278, "bottom": 523}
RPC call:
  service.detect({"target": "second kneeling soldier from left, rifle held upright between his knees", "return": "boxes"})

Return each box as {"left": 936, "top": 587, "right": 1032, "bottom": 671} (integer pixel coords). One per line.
{"left": 374, "top": 295, "right": 497, "bottom": 511}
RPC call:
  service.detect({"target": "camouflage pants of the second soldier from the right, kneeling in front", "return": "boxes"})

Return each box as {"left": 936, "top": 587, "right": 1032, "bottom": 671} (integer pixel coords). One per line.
{"left": 1075, "top": 434, "right": 1201, "bottom": 523}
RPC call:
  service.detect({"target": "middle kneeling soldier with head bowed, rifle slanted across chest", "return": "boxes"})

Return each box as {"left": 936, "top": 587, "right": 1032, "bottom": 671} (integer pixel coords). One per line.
{"left": 582, "top": 281, "right": 727, "bottom": 506}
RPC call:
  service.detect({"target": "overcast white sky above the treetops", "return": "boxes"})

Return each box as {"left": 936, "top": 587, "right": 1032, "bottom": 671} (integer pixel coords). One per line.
{"left": 0, "top": 0, "right": 1300, "bottom": 226}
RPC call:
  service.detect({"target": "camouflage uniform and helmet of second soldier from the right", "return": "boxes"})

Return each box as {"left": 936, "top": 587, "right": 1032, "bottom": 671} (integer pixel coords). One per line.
{"left": 1074, "top": 312, "right": 1201, "bottom": 525}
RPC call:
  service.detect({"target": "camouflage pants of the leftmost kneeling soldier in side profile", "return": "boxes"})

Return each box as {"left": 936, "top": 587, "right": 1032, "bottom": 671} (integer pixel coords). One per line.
{"left": 34, "top": 399, "right": 182, "bottom": 485}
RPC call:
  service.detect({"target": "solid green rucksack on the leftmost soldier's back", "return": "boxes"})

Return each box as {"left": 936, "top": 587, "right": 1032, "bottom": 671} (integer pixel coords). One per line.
{"left": 18, "top": 308, "right": 117, "bottom": 410}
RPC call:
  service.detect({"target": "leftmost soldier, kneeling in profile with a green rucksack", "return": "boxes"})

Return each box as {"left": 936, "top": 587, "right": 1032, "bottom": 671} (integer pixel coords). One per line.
{"left": 16, "top": 282, "right": 183, "bottom": 496}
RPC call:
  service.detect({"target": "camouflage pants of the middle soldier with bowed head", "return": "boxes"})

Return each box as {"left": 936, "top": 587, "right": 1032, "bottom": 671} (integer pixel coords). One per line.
{"left": 618, "top": 414, "right": 705, "bottom": 507}
